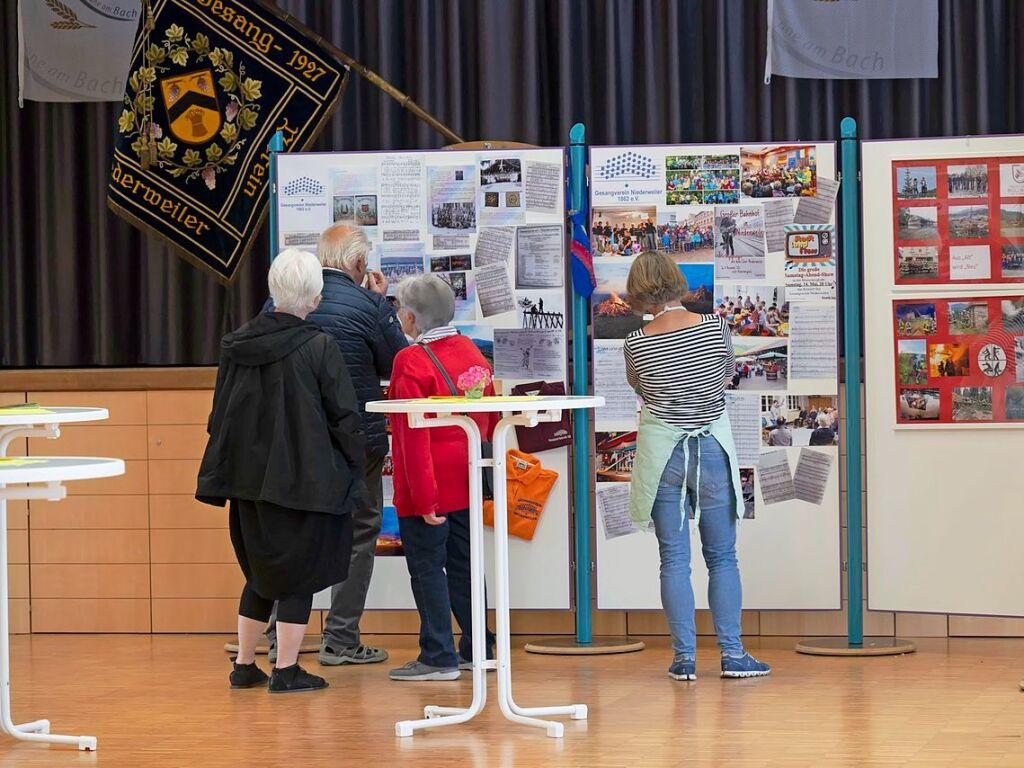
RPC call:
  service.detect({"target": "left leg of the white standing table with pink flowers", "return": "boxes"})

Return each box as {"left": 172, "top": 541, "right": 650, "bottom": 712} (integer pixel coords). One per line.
{"left": 394, "top": 414, "right": 494, "bottom": 736}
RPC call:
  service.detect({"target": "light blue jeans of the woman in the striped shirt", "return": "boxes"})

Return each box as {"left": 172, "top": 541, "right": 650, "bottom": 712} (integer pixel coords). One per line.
{"left": 651, "top": 435, "right": 743, "bottom": 658}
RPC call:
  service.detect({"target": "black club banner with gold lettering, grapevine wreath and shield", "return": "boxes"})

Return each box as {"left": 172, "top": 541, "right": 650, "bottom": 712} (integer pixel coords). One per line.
{"left": 108, "top": 0, "right": 344, "bottom": 282}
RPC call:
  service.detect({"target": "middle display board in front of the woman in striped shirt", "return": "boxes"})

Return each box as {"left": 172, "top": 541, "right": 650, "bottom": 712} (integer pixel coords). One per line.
{"left": 590, "top": 143, "right": 841, "bottom": 609}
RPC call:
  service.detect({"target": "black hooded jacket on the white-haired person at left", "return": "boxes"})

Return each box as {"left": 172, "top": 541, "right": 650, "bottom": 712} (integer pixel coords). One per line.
{"left": 196, "top": 312, "right": 366, "bottom": 515}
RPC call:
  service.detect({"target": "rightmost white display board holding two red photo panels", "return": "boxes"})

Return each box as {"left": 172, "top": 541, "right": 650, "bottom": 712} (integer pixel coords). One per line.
{"left": 862, "top": 136, "right": 1024, "bottom": 615}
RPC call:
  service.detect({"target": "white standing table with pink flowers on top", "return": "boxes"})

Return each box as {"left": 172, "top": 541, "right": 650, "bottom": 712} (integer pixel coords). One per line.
{"left": 367, "top": 395, "right": 604, "bottom": 738}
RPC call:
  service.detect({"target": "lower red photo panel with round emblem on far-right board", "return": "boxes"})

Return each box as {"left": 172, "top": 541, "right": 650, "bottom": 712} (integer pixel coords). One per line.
{"left": 893, "top": 296, "right": 1024, "bottom": 426}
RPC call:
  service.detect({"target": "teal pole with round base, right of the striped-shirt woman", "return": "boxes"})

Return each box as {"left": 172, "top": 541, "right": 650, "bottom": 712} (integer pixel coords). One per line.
{"left": 797, "top": 117, "right": 915, "bottom": 656}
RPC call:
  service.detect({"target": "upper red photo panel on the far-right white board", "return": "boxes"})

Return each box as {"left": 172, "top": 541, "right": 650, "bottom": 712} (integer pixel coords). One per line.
{"left": 892, "top": 157, "right": 1024, "bottom": 286}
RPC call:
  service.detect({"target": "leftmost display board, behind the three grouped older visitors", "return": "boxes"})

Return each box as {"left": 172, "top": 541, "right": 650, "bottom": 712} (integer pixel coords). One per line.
{"left": 275, "top": 148, "right": 571, "bottom": 609}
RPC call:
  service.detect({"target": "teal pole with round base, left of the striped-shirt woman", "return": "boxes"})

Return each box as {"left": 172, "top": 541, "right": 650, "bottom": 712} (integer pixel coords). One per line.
{"left": 526, "top": 123, "right": 644, "bottom": 654}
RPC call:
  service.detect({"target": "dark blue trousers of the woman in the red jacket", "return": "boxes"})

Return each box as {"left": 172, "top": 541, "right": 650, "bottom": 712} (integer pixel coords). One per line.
{"left": 398, "top": 511, "right": 495, "bottom": 670}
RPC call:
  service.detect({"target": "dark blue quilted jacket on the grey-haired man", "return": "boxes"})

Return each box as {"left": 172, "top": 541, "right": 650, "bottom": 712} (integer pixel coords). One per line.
{"left": 263, "top": 269, "right": 408, "bottom": 460}
